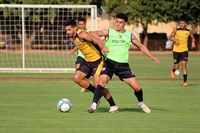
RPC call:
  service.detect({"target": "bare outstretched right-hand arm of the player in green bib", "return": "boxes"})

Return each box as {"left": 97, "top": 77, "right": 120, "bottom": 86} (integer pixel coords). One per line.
{"left": 132, "top": 35, "right": 160, "bottom": 64}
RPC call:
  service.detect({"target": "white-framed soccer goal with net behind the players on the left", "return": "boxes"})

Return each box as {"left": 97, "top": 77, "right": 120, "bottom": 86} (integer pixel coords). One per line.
{"left": 0, "top": 4, "right": 97, "bottom": 72}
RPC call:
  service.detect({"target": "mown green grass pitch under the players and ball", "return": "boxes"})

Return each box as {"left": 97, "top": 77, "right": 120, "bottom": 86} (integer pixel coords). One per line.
{"left": 0, "top": 55, "right": 200, "bottom": 133}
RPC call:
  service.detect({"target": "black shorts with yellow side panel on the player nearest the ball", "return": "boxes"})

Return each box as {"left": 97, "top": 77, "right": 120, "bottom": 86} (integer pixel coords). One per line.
{"left": 77, "top": 57, "right": 104, "bottom": 75}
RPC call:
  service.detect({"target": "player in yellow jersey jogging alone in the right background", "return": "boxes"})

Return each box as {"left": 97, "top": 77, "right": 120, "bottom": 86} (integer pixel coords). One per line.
{"left": 170, "top": 19, "right": 195, "bottom": 87}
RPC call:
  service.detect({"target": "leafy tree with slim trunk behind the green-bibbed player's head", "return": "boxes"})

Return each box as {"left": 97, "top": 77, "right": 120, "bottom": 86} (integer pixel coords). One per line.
{"left": 105, "top": 0, "right": 170, "bottom": 45}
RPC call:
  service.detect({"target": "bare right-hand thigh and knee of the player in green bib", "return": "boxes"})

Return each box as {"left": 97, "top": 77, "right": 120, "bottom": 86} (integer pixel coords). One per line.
{"left": 123, "top": 77, "right": 140, "bottom": 91}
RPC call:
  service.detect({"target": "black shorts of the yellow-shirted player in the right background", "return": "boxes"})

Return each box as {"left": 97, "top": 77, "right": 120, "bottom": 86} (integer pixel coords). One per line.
{"left": 173, "top": 51, "right": 188, "bottom": 64}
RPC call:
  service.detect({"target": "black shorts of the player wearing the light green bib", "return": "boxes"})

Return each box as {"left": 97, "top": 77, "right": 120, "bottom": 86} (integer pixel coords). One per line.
{"left": 101, "top": 59, "right": 135, "bottom": 81}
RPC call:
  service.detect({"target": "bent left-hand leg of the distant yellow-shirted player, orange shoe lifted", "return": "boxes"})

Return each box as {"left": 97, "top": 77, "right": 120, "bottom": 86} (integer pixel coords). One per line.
{"left": 171, "top": 52, "right": 180, "bottom": 78}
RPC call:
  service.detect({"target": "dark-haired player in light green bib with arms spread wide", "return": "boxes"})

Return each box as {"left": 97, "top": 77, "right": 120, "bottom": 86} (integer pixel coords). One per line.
{"left": 87, "top": 13, "right": 159, "bottom": 113}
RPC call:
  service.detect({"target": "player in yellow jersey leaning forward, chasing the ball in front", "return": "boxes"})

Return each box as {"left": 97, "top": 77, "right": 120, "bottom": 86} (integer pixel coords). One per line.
{"left": 65, "top": 19, "right": 116, "bottom": 111}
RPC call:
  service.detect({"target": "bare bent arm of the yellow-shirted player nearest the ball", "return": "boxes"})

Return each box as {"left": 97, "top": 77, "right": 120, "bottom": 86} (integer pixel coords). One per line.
{"left": 79, "top": 31, "right": 109, "bottom": 54}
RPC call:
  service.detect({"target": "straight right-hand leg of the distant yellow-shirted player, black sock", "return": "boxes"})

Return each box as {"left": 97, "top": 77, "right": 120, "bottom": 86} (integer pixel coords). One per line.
{"left": 181, "top": 51, "right": 188, "bottom": 87}
